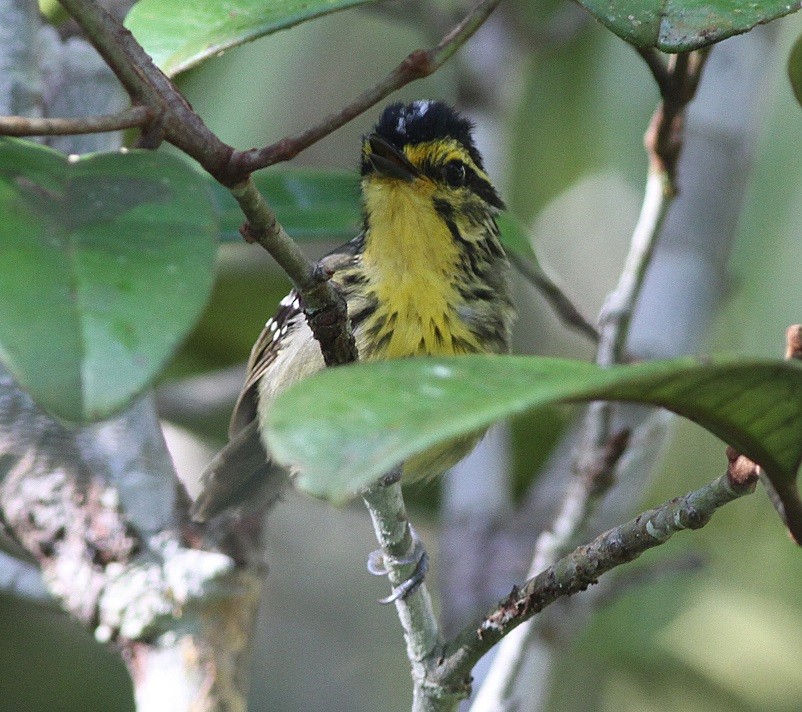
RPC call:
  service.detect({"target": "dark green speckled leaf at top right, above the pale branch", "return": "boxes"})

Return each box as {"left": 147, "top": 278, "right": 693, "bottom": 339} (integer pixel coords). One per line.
{"left": 580, "top": 0, "right": 800, "bottom": 52}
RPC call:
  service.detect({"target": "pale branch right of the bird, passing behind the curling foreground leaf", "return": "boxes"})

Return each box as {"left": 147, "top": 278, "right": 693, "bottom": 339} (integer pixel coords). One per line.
{"left": 468, "top": 51, "right": 707, "bottom": 709}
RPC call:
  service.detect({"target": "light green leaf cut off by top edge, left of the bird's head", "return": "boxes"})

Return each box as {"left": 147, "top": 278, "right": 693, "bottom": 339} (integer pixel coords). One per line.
{"left": 125, "top": 0, "right": 374, "bottom": 77}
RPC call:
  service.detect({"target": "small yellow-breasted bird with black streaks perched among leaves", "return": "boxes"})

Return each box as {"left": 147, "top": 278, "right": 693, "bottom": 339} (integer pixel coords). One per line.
{"left": 192, "top": 100, "right": 515, "bottom": 522}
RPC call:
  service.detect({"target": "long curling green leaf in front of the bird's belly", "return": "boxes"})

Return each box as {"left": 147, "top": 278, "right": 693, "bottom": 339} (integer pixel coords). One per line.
{"left": 266, "top": 356, "right": 802, "bottom": 541}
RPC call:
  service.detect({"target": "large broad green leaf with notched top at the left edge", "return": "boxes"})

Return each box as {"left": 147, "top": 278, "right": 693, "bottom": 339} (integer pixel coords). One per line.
{"left": 0, "top": 139, "right": 217, "bottom": 421}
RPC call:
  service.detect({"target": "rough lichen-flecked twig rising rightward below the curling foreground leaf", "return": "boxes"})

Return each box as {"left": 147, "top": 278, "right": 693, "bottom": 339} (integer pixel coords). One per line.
{"left": 438, "top": 469, "right": 757, "bottom": 680}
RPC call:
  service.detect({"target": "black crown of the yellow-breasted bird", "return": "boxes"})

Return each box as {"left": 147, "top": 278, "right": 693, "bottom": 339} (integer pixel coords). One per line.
{"left": 373, "top": 100, "right": 484, "bottom": 170}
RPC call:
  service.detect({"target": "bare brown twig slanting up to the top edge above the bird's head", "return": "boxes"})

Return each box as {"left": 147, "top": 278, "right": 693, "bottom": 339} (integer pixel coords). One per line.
{"left": 232, "top": 0, "right": 501, "bottom": 172}
